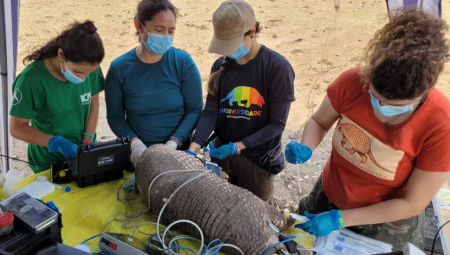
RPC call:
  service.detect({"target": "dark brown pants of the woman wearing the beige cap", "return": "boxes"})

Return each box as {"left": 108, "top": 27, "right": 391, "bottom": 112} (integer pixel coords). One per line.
{"left": 212, "top": 155, "right": 275, "bottom": 201}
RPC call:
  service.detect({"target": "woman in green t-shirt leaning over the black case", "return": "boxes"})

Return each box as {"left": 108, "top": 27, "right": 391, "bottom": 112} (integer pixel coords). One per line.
{"left": 10, "top": 21, "right": 105, "bottom": 173}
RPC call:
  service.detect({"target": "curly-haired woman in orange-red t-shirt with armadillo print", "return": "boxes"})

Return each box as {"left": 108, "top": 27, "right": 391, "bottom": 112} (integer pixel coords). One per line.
{"left": 286, "top": 9, "right": 450, "bottom": 250}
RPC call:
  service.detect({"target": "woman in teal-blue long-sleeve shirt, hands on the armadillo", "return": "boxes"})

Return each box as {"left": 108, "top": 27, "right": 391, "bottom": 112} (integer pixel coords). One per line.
{"left": 105, "top": 0, "right": 203, "bottom": 167}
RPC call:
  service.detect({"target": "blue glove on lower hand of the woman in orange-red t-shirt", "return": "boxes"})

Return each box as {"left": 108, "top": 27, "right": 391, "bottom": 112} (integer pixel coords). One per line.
{"left": 295, "top": 210, "right": 339, "bottom": 237}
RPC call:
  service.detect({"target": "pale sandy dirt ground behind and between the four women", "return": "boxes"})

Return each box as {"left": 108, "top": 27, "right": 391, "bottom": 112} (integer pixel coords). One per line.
{"left": 9, "top": 0, "right": 450, "bottom": 229}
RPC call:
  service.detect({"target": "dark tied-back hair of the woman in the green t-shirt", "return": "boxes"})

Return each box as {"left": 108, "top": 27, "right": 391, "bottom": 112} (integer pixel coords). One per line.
{"left": 23, "top": 20, "right": 105, "bottom": 65}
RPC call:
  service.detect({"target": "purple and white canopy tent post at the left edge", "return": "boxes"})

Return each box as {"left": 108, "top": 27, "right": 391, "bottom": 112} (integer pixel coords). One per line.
{"left": 0, "top": 0, "right": 22, "bottom": 174}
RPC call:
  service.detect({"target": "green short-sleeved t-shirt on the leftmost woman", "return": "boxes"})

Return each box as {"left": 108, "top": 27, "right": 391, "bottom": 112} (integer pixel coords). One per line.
{"left": 10, "top": 60, "right": 104, "bottom": 173}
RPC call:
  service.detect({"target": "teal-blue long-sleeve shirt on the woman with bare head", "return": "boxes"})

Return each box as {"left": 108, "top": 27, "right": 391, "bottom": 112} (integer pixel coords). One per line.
{"left": 105, "top": 48, "right": 203, "bottom": 146}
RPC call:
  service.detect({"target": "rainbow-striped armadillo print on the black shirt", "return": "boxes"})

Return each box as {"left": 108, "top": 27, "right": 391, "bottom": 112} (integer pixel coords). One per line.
{"left": 220, "top": 86, "right": 266, "bottom": 108}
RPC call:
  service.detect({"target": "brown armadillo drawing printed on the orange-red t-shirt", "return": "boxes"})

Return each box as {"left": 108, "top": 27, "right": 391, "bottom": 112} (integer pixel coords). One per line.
{"left": 338, "top": 123, "right": 394, "bottom": 173}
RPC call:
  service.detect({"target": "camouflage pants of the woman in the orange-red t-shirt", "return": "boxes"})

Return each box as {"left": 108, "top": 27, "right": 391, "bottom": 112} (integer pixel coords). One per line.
{"left": 298, "top": 177, "right": 424, "bottom": 251}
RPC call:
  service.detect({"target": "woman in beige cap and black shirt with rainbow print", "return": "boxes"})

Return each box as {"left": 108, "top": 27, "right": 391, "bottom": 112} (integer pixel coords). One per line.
{"left": 189, "top": 0, "right": 295, "bottom": 200}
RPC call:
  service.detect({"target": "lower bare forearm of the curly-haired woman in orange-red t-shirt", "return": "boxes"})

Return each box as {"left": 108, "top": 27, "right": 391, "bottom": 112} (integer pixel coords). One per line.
{"left": 341, "top": 198, "right": 424, "bottom": 227}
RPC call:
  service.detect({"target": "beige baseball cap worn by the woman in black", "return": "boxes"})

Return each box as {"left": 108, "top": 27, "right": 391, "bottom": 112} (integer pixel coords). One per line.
{"left": 208, "top": 0, "right": 256, "bottom": 56}
